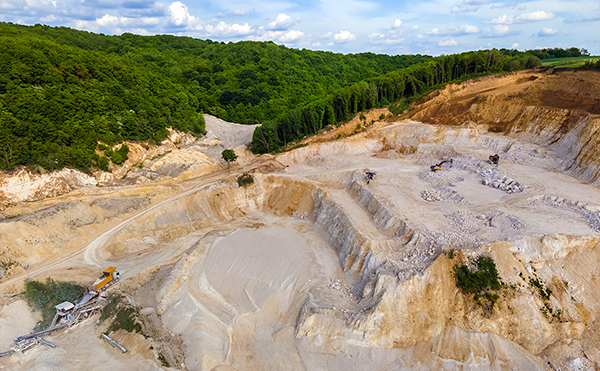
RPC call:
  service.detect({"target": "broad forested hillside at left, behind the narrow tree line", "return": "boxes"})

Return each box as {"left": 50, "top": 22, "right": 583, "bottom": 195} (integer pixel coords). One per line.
{"left": 0, "top": 23, "right": 429, "bottom": 172}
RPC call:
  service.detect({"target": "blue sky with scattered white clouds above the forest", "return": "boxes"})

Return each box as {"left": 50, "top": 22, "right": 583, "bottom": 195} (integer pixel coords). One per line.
{"left": 0, "top": 0, "right": 600, "bottom": 55}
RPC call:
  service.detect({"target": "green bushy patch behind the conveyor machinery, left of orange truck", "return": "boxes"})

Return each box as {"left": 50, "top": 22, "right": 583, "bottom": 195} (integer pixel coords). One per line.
{"left": 23, "top": 277, "right": 85, "bottom": 331}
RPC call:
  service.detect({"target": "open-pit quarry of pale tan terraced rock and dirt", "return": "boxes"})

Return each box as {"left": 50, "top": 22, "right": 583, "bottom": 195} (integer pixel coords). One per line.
{"left": 0, "top": 70, "right": 600, "bottom": 371}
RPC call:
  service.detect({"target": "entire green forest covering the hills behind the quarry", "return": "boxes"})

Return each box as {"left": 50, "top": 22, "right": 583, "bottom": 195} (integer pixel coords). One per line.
{"left": 0, "top": 23, "right": 575, "bottom": 172}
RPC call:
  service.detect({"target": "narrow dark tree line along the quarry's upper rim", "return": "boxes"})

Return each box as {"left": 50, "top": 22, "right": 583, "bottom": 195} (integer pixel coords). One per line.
{"left": 251, "top": 49, "right": 540, "bottom": 153}
